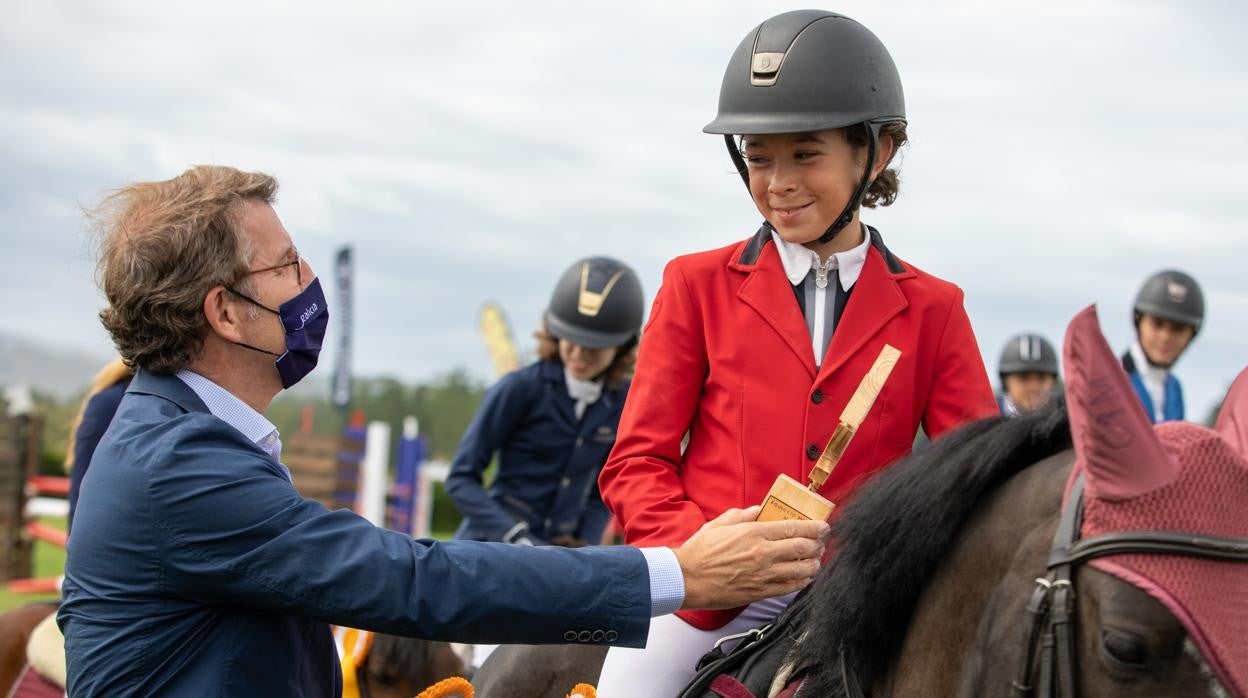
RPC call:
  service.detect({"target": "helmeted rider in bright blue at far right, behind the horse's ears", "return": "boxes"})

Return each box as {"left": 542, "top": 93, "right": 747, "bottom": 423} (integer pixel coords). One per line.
{"left": 1122, "top": 270, "right": 1204, "bottom": 423}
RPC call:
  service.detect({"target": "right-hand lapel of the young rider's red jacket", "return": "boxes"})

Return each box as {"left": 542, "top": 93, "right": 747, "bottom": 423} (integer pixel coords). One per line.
{"left": 819, "top": 227, "right": 914, "bottom": 380}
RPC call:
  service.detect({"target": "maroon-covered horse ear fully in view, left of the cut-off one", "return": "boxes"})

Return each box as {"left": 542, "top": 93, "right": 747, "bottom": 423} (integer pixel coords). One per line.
{"left": 1062, "top": 306, "right": 1178, "bottom": 499}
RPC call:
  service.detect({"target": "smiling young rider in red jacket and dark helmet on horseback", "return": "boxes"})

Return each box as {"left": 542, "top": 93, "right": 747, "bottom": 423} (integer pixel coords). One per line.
{"left": 599, "top": 10, "right": 997, "bottom": 696}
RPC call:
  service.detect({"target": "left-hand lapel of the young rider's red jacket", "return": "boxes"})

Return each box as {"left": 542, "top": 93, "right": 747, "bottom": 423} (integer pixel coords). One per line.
{"left": 729, "top": 226, "right": 815, "bottom": 380}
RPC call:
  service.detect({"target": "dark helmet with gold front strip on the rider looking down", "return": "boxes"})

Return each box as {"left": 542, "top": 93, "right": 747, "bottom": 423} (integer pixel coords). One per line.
{"left": 544, "top": 257, "right": 644, "bottom": 348}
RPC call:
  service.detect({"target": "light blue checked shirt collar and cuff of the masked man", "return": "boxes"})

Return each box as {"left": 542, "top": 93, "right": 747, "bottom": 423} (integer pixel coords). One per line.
{"left": 177, "top": 368, "right": 685, "bottom": 616}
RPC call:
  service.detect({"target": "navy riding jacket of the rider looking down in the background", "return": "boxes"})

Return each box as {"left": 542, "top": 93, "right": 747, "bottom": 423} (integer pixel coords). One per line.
{"left": 447, "top": 361, "right": 628, "bottom": 544}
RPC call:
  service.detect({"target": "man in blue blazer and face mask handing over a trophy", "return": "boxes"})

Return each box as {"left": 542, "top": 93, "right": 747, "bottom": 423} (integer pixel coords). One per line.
{"left": 59, "top": 166, "right": 826, "bottom": 697}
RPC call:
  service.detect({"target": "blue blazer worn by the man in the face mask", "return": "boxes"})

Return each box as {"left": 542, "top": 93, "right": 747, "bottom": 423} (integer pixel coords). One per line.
{"left": 59, "top": 371, "right": 650, "bottom": 697}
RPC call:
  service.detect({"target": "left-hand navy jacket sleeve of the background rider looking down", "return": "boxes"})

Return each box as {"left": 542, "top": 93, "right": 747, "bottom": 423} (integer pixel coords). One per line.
{"left": 446, "top": 372, "right": 530, "bottom": 541}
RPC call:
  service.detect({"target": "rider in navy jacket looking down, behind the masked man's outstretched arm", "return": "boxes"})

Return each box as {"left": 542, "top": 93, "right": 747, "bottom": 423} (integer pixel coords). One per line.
{"left": 447, "top": 257, "right": 643, "bottom": 547}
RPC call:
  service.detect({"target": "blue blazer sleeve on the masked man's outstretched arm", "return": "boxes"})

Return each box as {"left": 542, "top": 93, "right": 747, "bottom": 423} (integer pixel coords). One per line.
{"left": 147, "top": 416, "right": 650, "bottom": 647}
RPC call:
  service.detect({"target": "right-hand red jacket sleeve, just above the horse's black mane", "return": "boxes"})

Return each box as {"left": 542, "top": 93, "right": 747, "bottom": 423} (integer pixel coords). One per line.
{"left": 922, "top": 288, "right": 1000, "bottom": 440}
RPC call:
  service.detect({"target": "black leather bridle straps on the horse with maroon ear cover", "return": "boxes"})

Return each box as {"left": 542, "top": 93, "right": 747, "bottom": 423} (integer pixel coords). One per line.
{"left": 1012, "top": 472, "right": 1248, "bottom": 698}
